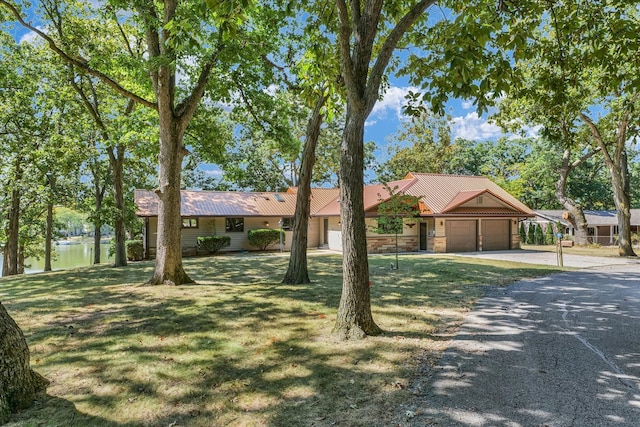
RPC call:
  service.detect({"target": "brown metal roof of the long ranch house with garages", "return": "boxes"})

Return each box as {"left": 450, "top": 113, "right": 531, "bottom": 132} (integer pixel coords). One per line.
{"left": 135, "top": 173, "right": 535, "bottom": 221}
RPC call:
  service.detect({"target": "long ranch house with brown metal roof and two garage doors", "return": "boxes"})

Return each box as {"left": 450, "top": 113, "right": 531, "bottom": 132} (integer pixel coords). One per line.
{"left": 135, "top": 173, "right": 535, "bottom": 256}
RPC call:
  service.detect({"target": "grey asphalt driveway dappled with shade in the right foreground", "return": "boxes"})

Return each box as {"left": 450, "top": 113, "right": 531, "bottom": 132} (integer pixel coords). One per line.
{"left": 400, "top": 262, "right": 640, "bottom": 427}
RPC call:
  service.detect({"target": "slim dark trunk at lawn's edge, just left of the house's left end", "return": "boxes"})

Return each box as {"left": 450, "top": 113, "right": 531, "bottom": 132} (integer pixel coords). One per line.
{"left": 107, "top": 144, "right": 127, "bottom": 267}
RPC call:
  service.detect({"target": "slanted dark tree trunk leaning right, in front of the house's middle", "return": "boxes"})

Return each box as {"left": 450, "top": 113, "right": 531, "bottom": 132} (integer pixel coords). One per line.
{"left": 282, "top": 94, "right": 327, "bottom": 284}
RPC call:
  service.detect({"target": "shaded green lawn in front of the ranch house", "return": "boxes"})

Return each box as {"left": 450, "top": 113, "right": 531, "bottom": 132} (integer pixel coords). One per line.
{"left": 0, "top": 255, "right": 557, "bottom": 426}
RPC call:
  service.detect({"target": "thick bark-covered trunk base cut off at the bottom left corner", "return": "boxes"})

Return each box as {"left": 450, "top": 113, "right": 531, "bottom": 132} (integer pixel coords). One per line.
{"left": 0, "top": 303, "right": 49, "bottom": 424}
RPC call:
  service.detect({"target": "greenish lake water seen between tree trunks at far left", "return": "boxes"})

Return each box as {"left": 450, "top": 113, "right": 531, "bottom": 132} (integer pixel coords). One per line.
{"left": 0, "top": 243, "right": 113, "bottom": 276}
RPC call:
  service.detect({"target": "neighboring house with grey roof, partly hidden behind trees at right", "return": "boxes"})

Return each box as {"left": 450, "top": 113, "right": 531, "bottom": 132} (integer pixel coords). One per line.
{"left": 532, "top": 209, "right": 640, "bottom": 246}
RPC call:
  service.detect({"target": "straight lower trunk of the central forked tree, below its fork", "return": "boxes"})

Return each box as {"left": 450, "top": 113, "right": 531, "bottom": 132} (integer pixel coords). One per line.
{"left": 333, "top": 106, "right": 382, "bottom": 340}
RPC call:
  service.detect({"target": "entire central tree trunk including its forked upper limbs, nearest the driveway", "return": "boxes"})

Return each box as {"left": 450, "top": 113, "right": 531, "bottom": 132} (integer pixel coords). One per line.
{"left": 333, "top": 0, "right": 434, "bottom": 339}
